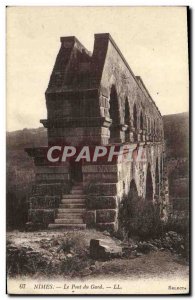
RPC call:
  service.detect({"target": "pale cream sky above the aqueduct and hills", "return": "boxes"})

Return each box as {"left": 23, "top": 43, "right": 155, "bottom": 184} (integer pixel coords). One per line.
{"left": 6, "top": 7, "right": 189, "bottom": 131}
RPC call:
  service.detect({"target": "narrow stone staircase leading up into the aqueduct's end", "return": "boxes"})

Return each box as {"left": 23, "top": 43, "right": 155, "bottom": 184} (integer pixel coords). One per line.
{"left": 49, "top": 183, "right": 86, "bottom": 229}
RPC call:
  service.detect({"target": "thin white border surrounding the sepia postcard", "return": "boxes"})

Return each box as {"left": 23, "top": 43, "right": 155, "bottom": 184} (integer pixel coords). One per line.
{"left": 0, "top": 0, "right": 195, "bottom": 299}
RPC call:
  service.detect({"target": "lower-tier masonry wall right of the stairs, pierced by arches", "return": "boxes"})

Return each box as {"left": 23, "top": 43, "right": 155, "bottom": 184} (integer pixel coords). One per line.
{"left": 83, "top": 144, "right": 168, "bottom": 231}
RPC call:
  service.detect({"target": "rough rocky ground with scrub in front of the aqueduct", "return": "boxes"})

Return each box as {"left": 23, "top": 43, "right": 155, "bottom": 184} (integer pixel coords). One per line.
{"left": 7, "top": 230, "right": 189, "bottom": 278}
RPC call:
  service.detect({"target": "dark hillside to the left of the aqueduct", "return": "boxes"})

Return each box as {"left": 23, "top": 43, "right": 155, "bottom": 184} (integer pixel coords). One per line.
{"left": 6, "top": 128, "right": 47, "bottom": 228}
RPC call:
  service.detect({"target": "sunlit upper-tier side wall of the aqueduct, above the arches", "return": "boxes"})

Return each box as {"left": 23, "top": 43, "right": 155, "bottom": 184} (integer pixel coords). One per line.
{"left": 97, "top": 35, "right": 164, "bottom": 142}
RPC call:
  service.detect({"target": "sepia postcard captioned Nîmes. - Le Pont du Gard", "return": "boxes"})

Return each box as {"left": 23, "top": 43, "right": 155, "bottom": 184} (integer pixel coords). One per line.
{"left": 6, "top": 6, "right": 190, "bottom": 295}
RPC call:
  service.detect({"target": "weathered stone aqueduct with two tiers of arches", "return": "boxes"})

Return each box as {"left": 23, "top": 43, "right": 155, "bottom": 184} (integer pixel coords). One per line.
{"left": 26, "top": 33, "right": 168, "bottom": 230}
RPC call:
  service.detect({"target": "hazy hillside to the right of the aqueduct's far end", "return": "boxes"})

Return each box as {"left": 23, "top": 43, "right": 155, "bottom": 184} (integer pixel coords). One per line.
{"left": 163, "top": 113, "right": 189, "bottom": 220}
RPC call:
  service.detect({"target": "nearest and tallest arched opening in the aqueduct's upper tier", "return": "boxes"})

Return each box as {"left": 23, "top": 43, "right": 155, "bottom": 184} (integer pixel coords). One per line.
{"left": 109, "top": 86, "right": 120, "bottom": 142}
